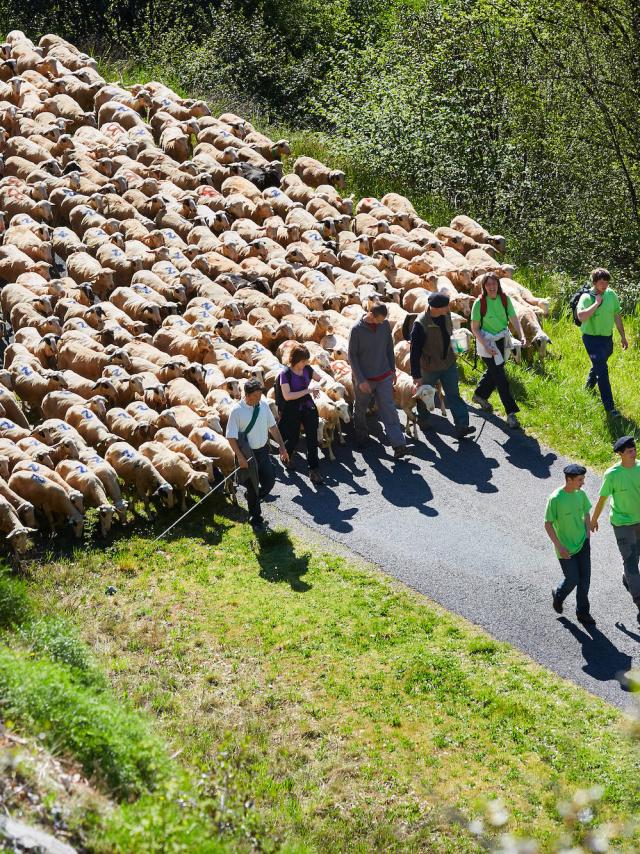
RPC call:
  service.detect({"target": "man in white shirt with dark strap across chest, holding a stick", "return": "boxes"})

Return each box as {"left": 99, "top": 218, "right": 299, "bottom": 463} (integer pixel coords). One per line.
{"left": 226, "top": 379, "right": 289, "bottom": 532}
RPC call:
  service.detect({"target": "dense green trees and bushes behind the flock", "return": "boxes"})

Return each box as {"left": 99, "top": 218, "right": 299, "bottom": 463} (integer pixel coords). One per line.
{"left": 0, "top": 0, "right": 640, "bottom": 300}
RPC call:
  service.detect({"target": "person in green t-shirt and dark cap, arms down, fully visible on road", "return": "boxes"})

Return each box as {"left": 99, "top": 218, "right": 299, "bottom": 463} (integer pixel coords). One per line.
{"left": 544, "top": 463, "right": 595, "bottom": 626}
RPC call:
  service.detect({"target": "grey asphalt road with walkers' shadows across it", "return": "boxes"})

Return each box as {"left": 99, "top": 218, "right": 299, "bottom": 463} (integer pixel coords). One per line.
{"left": 265, "top": 410, "right": 640, "bottom": 710}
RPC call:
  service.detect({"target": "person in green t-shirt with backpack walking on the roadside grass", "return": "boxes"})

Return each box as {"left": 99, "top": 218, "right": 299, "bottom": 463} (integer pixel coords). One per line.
{"left": 577, "top": 267, "right": 629, "bottom": 418}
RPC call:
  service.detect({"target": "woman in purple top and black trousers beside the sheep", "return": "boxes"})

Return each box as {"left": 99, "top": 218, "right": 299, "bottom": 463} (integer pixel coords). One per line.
{"left": 276, "top": 344, "right": 322, "bottom": 483}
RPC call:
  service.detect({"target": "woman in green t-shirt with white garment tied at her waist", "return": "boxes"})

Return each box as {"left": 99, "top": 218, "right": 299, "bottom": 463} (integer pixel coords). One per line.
{"left": 471, "top": 273, "right": 525, "bottom": 430}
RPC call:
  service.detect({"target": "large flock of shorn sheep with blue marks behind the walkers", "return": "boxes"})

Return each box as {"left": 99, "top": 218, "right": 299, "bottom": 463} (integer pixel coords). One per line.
{"left": 0, "top": 31, "right": 548, "bottom": 556}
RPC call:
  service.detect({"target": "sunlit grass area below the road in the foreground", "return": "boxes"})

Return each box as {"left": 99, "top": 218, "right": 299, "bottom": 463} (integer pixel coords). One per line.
{"left": 0, "top": 508, "right": 639, "bottom": 852}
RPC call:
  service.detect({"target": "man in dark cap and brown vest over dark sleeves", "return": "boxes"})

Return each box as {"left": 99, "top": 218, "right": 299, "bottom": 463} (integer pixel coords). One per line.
{"left": 410, "top": 291, "right": 475, "bottom": 439}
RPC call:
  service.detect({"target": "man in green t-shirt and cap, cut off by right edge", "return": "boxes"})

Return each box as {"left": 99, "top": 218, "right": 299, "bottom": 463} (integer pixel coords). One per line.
{"left": 591, "top": 436, "right": 640, "bottom": 623}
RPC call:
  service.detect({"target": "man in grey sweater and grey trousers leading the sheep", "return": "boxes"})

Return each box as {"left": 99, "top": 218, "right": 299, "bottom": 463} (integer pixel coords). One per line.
{"left": 349, "top": 303, "right": 407, "bottom": 459}
